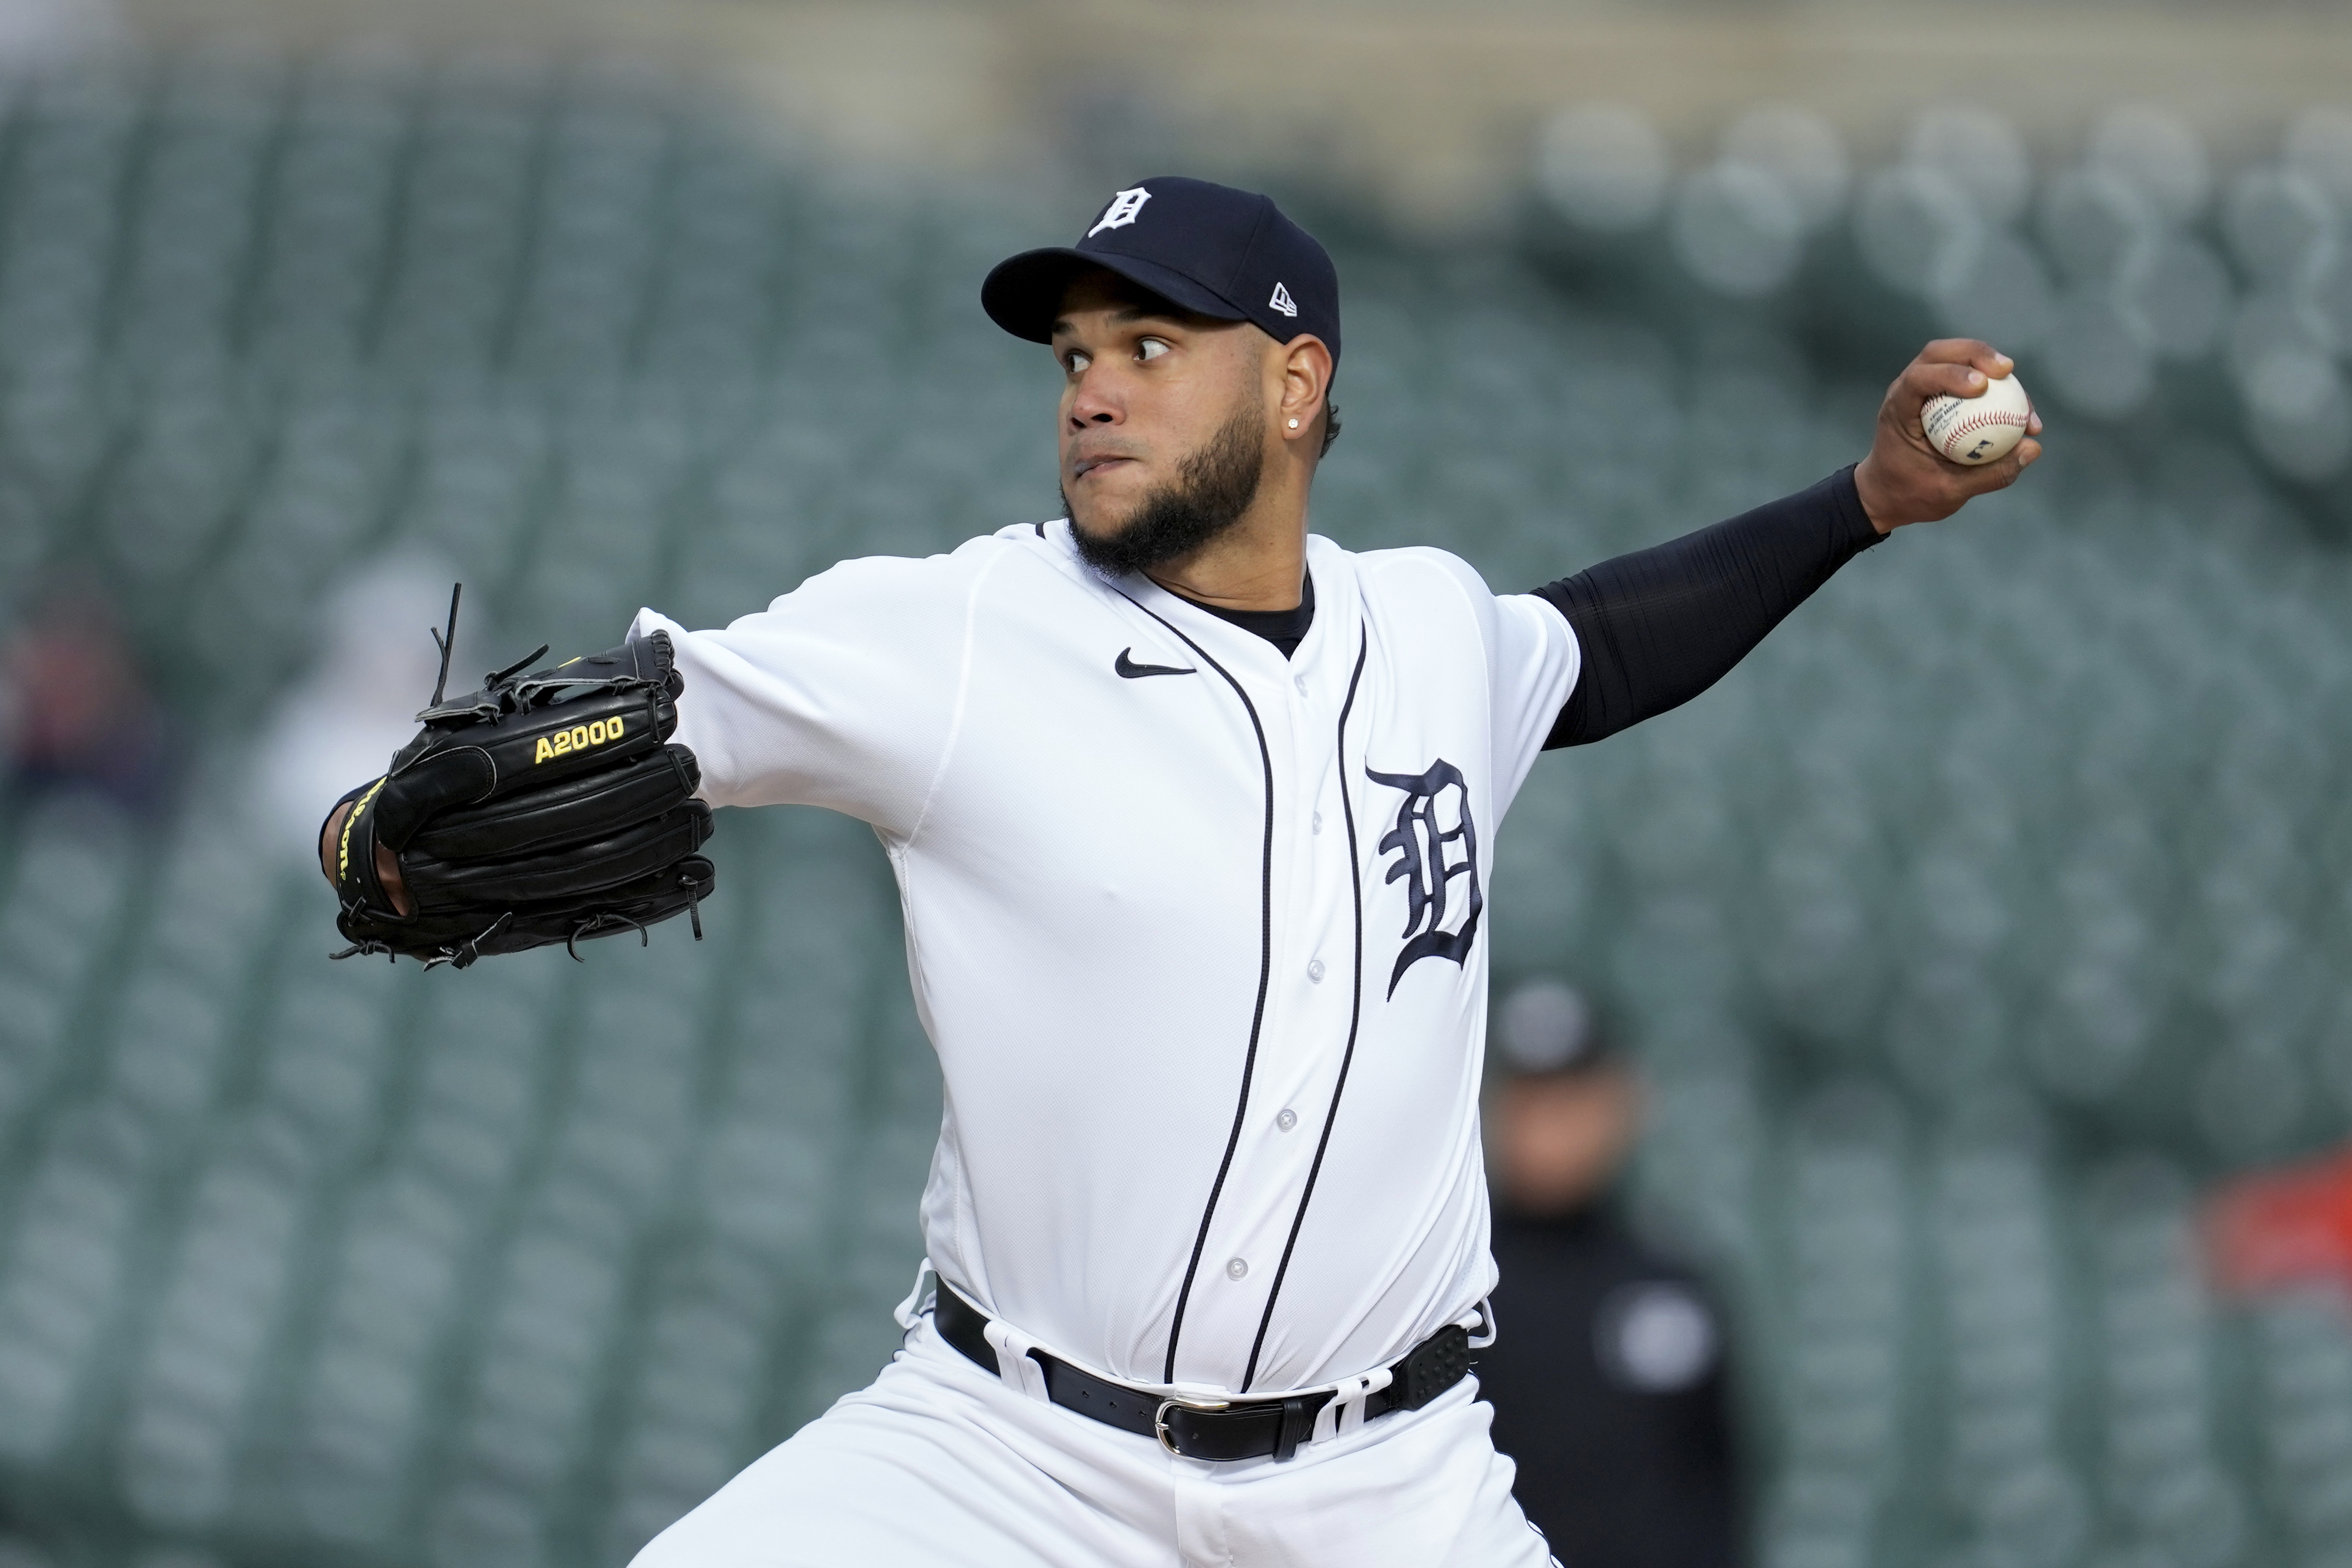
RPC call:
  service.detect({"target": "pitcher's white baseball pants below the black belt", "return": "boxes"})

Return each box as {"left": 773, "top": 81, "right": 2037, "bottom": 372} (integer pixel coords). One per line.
{"left": 633, "top": 1316, "right": 1557, "bottom": 1568}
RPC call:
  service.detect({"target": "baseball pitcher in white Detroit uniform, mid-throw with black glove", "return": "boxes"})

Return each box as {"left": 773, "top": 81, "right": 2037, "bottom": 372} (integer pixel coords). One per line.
{"left": 320, "top": 179, "right": 2039, "bottom": 1568}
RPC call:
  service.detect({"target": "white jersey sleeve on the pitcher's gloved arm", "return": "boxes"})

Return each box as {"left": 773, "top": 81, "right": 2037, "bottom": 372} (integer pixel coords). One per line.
{"left": 630, "top": 538, "right": 1002, "bottom": 837}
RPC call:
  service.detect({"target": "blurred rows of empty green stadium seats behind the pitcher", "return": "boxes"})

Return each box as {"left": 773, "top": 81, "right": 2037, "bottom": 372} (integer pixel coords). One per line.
{"left": 0, "top": 64, "right": 2352, "bottom": 1568}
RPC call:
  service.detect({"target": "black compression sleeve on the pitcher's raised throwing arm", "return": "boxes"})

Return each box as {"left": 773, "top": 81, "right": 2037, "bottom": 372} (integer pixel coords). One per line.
{"left": 1536, "top": 468, "right": 1884, "bottom": 750}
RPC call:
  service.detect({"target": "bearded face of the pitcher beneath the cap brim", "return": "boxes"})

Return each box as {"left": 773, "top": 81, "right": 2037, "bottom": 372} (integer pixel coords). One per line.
{"left": 1054, "top": 270, "right": 1272, "bottom": 571}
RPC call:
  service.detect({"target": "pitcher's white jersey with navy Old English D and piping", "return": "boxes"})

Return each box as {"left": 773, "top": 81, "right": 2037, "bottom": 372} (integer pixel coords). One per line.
{"left": 638, "top": 522, "right": 1578, "bottom": 1396}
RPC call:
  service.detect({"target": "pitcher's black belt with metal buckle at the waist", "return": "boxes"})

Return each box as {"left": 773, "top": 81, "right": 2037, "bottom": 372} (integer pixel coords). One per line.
{"left": 931, "top": 1281, "right": 1470, "bottom": 1460}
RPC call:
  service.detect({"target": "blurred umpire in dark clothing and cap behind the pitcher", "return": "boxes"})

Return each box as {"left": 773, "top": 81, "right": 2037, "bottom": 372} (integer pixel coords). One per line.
{"left": 1477, "top": 980, "right": 1741, "bottom": 1568}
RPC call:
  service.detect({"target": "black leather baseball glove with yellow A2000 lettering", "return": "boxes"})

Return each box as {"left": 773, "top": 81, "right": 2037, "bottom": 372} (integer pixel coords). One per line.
{"left": 320, "top": 585, "right": 715, "bottom": 969}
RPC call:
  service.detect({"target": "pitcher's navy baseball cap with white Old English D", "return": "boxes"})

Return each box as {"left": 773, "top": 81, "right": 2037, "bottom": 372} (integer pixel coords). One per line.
{"left": 981, "top": 174, "right": 1338, "bottom": 365}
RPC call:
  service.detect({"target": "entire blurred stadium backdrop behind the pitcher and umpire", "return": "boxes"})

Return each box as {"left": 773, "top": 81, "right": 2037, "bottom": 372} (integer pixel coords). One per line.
{"left": 0, "top": 0, "right": 2352, "bottom": 1568}
